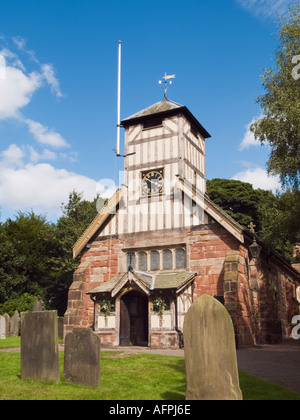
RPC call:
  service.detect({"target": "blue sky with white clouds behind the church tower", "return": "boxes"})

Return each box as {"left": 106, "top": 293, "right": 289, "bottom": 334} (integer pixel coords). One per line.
{"left": 0, "top": 0, "right": 293, "bottom": 221}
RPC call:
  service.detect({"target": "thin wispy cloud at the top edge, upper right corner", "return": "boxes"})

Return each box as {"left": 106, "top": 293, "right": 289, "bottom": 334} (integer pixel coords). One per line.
{"left": 236, "top": 0, "right": 293, "bottom": 18}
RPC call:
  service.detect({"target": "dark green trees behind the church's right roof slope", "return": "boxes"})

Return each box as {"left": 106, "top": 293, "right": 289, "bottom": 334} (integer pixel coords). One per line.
{"left": 207, "top": 179, "right": 300, "bottom": 262}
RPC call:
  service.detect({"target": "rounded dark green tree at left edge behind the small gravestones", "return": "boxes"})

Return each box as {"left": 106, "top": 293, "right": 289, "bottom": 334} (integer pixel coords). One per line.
{"left": 0, "top": 212, "right": 56, "bottom": 302}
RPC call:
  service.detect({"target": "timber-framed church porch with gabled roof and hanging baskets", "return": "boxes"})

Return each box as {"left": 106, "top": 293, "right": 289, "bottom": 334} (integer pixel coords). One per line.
{"left": 89, "top": 269, "right": 195, "bottom": 349}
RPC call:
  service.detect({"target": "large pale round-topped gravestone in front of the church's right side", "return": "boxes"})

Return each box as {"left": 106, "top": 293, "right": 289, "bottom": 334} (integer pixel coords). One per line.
{"left": 183, "top": 295, "right": 242, "bottom": 400}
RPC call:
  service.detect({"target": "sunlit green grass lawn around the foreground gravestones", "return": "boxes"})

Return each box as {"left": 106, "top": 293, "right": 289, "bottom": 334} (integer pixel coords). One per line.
{"left": 0, "top": 346, "right": 300, "bottom": 400}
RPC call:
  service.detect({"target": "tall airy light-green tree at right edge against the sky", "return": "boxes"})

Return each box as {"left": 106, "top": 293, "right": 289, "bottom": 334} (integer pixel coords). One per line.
{"left": 251, "top": 2, "right": 300, "bottom": 188}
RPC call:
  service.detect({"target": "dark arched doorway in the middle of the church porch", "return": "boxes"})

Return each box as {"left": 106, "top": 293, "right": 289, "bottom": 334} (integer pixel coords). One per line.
{"left": 120, "top": 291, "right": 148, "bottom": 346}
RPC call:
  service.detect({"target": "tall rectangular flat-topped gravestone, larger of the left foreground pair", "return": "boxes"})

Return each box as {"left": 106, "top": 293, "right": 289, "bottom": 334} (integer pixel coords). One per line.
{"left": 21, "top": 311, "right": 59, "bottom": 382}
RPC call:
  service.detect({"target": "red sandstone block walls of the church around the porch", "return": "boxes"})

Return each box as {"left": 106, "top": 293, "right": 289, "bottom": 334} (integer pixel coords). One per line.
{"left": 65, "top": 223, "right": 299, "bottom": 348}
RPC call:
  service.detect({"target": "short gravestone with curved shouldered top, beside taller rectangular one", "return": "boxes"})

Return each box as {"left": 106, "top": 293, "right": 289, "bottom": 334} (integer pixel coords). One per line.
{"left": 64, "top": 328, "right": 100, "bottom": 387}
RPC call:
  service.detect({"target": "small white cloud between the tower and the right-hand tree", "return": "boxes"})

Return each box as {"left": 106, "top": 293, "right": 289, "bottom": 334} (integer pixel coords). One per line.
{"left": 232, "top": 168, "right": 281, "bottom": 192}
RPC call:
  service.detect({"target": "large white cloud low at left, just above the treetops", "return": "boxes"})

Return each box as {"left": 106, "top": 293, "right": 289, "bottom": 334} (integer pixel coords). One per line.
{"left": 0, "top": 155, "right": 97, "bottom": 217}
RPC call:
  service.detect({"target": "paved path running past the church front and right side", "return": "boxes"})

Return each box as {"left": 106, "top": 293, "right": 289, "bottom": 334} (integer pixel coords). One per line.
{"left": 0, "top": 340, "right": 300, "bottom": 394}
